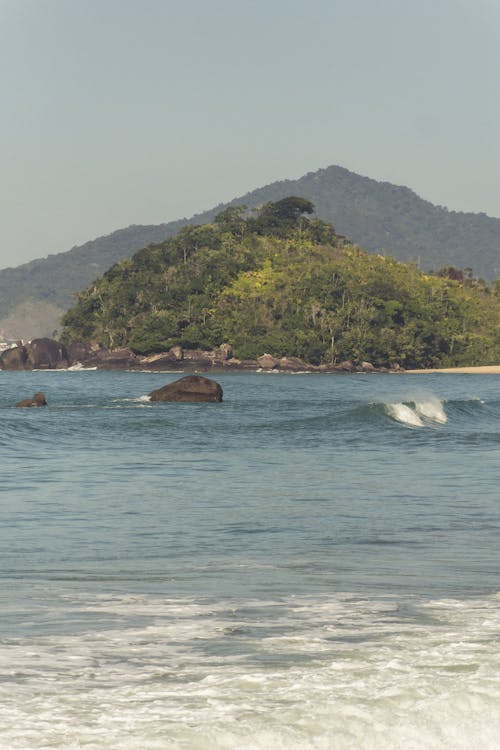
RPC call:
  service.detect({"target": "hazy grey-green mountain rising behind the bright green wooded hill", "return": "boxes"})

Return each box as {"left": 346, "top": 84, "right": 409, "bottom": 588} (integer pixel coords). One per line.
{"left": 0, "top": 166, "right": 500, "bottom": 337}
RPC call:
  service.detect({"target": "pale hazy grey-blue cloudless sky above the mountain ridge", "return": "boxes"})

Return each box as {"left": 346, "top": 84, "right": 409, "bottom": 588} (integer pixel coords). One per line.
{"left": 0, "top": 0, "right": 500, "bottom": 268}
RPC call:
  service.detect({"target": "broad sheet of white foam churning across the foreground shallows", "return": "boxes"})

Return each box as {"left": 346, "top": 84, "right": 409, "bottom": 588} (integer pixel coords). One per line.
{"left": 0, "top": 595, "right": 500, "bottom": 750}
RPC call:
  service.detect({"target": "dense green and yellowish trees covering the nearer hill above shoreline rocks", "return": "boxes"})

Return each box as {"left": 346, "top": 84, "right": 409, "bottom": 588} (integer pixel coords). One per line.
{"left": 62, "top": 197, "right": 500, "bottom": 367}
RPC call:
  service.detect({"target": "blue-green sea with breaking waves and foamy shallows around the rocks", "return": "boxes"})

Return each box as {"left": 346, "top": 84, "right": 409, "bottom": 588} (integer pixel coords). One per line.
{"left": 0, "top": 371, "right": 500, "bottom": 750}
